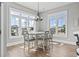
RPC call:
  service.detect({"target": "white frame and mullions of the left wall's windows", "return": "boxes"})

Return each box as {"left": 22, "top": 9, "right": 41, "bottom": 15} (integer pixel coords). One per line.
{"left": 8, "top": 7, "right": 36, "bottom": 38}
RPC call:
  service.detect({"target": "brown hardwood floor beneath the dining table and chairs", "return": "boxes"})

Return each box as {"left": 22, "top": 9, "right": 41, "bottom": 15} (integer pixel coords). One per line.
{"left": 7, "top": 42, "right": 77, "bottom": 57}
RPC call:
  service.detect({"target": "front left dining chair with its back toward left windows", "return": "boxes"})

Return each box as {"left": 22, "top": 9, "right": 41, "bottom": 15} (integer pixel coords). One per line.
{"left": 23, "top": 28, "right": 35, "bottom": 52}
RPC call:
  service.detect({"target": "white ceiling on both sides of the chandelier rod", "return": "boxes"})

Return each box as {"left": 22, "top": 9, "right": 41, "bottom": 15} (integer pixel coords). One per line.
{"left": 17, "top": 2, "right": 72, "bottom": 12}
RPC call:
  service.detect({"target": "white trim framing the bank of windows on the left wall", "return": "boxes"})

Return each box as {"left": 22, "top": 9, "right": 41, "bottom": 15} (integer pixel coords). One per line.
{"left": 8, "top": 7, "right": 36, "bottom": 38}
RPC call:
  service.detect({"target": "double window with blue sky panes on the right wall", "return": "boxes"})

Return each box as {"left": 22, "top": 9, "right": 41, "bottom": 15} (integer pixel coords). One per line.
{"left": 49, "top": 11, "right": 67, "bottom": 36}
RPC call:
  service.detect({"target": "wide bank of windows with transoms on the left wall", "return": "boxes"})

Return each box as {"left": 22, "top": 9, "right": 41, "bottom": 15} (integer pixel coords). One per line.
{"left": 10, "top": 8, "right": 35, "bottom": 36}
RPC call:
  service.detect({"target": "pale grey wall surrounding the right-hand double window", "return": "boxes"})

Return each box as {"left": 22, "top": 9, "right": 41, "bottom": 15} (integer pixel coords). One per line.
{"left": 40, "top": 3, "right": 79, "bottom": 44}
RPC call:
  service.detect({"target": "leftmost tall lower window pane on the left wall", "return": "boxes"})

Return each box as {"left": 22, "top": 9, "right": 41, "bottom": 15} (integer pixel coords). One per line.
{"left": 11, "top": 16, "right": 19, "bottom": 36}
